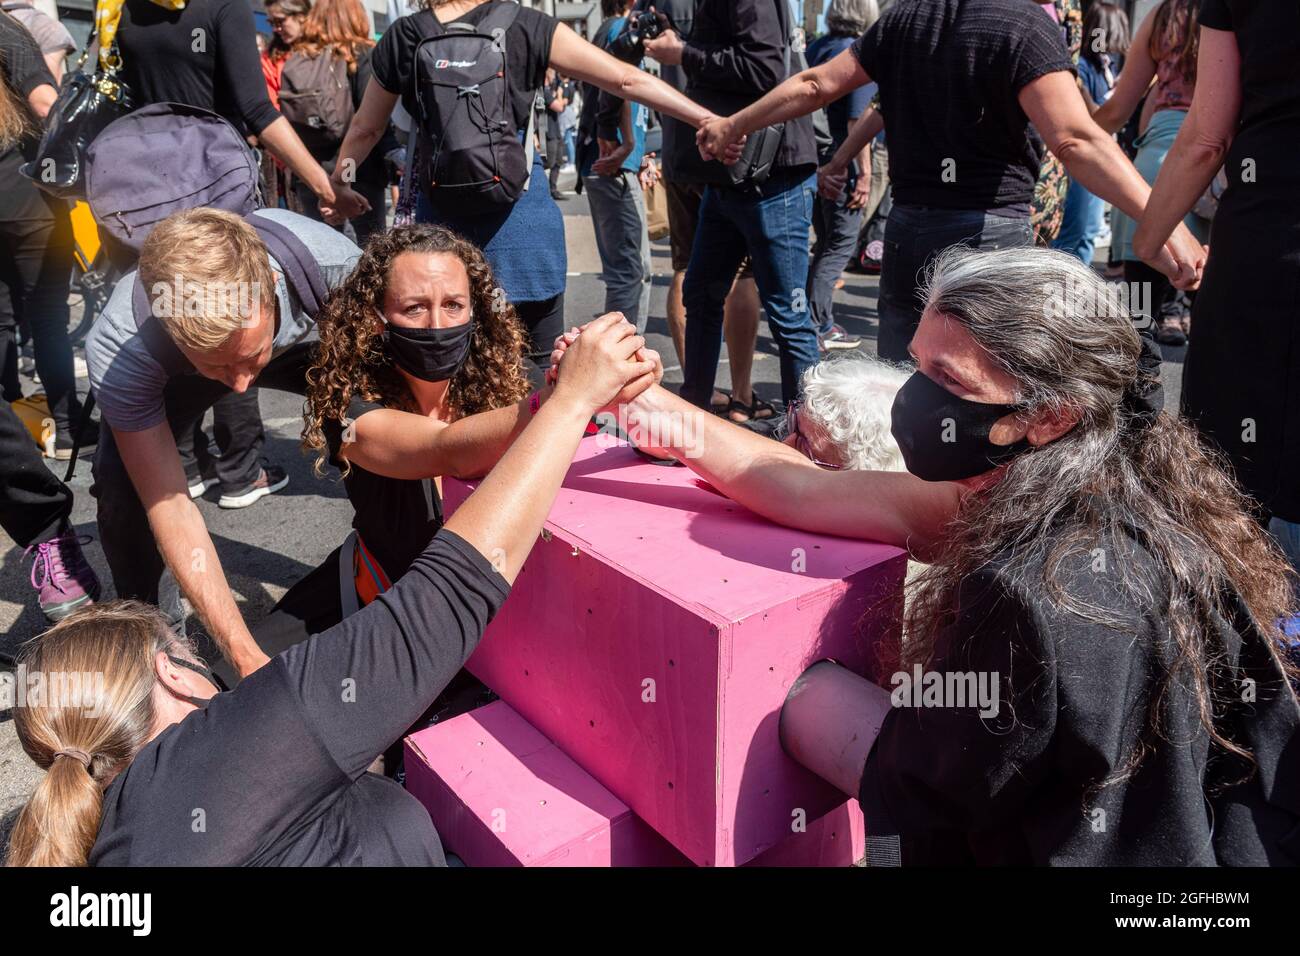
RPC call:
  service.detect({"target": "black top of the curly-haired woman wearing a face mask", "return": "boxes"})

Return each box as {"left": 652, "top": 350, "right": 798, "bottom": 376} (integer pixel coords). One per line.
{"left": 322, "top": 398, "right": 442, "bottom": 581}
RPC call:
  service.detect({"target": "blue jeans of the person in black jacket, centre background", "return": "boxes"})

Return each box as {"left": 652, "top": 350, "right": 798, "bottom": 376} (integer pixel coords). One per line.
{"left": 681, "top": 169, "right": 819, "bottom": 408}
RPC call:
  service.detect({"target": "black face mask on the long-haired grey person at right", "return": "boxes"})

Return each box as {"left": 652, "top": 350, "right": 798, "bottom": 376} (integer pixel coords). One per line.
{"left": 889, "top": 372, "right": 1030, "bottom": 481}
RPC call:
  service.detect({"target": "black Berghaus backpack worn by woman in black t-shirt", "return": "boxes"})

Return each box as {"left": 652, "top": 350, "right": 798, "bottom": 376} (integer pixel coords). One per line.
{"left": 412, "top": 0, "right": 532, "bottom": 213}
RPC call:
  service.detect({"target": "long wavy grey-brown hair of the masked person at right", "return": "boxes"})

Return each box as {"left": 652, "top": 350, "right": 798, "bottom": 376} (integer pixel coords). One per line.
{"left": 900, "top": 246, "right": 1296, "bottom": 792}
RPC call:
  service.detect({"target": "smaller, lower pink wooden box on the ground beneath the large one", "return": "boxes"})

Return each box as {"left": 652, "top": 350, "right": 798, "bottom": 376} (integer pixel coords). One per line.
{"left": 406, "top": 701, "right": 690, "bottom": 866}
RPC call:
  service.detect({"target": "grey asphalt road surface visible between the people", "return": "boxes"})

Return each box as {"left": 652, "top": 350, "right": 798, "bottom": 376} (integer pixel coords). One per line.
{"left": 0, "top": 177, "right": 1186, "bottom": 842}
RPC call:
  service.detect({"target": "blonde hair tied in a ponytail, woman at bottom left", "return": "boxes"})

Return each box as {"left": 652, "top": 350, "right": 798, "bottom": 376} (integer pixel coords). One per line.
{"left": 5, "top": 601, "right": 177, "bottom": 866}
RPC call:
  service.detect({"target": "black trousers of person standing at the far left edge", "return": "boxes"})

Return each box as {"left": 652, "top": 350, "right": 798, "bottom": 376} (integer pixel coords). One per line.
{"left": 0, "top": 188, "right": 78, "bottom": 429}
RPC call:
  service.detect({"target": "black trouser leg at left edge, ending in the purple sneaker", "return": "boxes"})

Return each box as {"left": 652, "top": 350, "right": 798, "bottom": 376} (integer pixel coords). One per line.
{"left": 0, "top": 402, "right": 73, "bottom": 548}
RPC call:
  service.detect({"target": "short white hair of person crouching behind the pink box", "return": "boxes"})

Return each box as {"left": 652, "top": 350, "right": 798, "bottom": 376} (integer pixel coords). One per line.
{"left": 800, "top": 355, "right": 909, "bottom": 471}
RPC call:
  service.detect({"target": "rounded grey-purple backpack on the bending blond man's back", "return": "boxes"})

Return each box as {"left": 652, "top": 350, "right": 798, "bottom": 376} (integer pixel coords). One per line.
{"left": 86, "top": 103, "right": 260, "bottom": 252}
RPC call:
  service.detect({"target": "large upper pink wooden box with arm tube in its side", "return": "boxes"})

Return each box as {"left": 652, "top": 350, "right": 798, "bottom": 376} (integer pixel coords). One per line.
{"left": 443, "top": 434, "right": 906, "bottom": 866}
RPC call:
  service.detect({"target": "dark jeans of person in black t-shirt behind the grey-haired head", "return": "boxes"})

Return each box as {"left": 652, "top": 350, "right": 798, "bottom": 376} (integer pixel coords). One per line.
{"left": 876, "top": 203, "right": 1034, "bottom": 362}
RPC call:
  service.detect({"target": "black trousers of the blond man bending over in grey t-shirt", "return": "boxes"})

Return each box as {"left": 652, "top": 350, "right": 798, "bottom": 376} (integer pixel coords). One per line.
{"left": 91, "top": 339, "right": 316, "bottom": 624}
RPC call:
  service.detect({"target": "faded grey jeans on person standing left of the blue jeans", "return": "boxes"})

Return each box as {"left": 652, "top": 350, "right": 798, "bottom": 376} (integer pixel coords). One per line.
{"left": 584, "top": 169, "right": 650, "bottom": 332}
